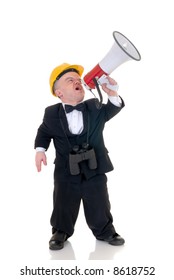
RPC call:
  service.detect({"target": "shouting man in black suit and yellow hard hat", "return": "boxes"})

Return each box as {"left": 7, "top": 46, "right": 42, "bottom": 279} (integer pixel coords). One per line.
{"left": 35, "top": 63, "right": 125, "bottom": 250}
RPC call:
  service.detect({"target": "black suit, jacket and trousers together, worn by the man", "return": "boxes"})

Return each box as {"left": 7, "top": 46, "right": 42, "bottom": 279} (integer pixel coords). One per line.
{"left": 35, "top": 99, "right": 124, "bottom": 239}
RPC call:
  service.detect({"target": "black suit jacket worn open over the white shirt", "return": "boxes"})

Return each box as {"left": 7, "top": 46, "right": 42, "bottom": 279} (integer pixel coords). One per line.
{"left": 35, "top": 98, "right": 124, "bottom": 178}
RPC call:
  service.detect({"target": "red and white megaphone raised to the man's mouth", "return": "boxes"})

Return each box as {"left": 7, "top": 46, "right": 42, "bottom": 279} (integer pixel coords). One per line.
{"left": 83, "top": 31, "right": 141, "bottom": 93}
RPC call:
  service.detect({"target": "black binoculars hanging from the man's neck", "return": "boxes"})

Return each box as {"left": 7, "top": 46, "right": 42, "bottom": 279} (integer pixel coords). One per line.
{"left": 69, "top": 143, "right": 97, "bottom": 175}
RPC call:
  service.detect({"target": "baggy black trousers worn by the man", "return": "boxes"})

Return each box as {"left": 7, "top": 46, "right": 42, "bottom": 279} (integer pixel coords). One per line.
{"left": 51, "top": 173, "right": 116, "bottom": 239}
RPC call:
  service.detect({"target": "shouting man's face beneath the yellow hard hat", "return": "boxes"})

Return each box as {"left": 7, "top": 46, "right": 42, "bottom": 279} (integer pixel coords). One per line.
{"left": 55, "top": 72, "right": 85, "bottom": 105}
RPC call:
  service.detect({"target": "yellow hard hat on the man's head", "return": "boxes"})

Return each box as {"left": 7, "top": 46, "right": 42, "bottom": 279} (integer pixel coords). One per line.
{"left": 50, "top": 63, "right": 84, "bottom": 96}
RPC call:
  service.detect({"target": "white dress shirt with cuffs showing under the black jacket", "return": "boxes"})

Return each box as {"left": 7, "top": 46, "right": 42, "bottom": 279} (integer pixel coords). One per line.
{"left": 36, "top": 96, "right": 122, "bottom": 152}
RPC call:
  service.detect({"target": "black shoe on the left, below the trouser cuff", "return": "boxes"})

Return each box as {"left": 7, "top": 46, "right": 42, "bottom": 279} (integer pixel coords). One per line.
{"left": 49, "top": 231, "right": 67, "bottom": 250}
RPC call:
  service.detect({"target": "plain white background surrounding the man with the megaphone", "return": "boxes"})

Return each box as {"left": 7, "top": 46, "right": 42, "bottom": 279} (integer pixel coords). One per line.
{"left": 0, "top": 0, "right": 174, "bottom": 279}
